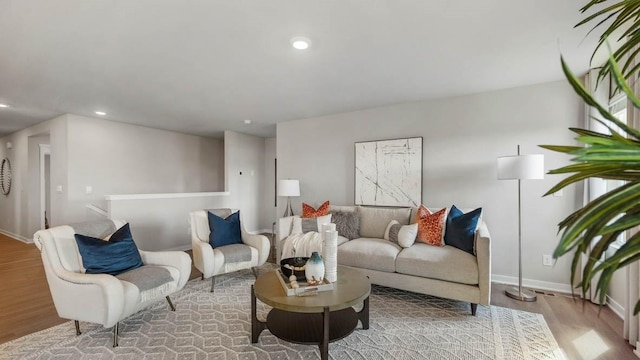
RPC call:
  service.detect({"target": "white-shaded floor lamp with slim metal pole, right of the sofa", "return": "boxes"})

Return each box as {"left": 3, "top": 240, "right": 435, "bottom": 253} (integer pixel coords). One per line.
{"left": 498, "top": 145, "right": 544, "bottom": 301}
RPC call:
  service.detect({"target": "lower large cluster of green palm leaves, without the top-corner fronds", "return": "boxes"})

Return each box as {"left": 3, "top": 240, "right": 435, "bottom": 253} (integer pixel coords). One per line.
{"left": 541, "top": 52, "right": 640, "bottom": 313}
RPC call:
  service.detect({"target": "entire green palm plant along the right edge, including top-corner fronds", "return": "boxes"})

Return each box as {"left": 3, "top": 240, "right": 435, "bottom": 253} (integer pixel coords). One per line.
{"left": 542, "top": 0, "right": 640, "bottom": 314}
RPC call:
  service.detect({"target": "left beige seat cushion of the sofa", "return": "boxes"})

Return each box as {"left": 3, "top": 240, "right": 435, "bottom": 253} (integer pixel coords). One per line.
{"left": 338, "top": 238, "right": 401, "bottom": 272}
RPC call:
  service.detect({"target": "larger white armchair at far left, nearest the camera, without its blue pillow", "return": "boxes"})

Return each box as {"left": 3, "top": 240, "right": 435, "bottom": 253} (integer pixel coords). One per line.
{"left": 34, "top": 220, "right": 191, "bottom": 347}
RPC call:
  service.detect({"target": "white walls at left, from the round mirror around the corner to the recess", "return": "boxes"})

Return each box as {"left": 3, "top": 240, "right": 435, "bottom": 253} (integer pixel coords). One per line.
{"left": 0, "top": 114, "right": 224, "bottom": 240}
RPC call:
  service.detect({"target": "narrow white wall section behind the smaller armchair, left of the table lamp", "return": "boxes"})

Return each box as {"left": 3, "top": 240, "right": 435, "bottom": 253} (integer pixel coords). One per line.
{"left": 224, "top": 131, "right": 270, "bottom": 231}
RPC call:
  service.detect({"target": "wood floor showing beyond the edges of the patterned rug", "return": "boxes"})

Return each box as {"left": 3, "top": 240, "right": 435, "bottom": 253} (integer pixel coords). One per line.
{"left": 0, "top": 234, "right": 637, "bottom": 360}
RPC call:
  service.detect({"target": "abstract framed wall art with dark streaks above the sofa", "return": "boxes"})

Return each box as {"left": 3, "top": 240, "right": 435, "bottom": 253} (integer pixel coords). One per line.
{"left": 355, "top": 137, "right": 422, "bottom": 206}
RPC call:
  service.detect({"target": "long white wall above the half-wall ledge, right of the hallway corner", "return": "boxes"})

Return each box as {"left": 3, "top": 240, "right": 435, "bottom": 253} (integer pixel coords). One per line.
{"left": 64, "top": 115, "right": 224, "bottom": 219}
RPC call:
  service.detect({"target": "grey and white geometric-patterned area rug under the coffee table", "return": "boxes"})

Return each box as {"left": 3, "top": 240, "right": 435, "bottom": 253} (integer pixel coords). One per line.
{"left": 0, "top": 267, "right": 564, "bottom": 360}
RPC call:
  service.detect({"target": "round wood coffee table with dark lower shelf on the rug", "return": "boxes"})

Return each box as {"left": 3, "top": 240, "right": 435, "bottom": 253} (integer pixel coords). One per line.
{"left": 251, "top": 266, "right": 371, "bottom": 360}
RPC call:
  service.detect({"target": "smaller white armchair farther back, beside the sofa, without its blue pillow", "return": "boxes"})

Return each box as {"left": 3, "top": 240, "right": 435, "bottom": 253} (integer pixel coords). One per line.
{"left": 189, "top": 209, "right": 271, "bottom": 292}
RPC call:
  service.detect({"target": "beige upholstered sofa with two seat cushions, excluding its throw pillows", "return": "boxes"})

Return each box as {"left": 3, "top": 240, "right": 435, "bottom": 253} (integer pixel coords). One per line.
{"left": 276, "top": 206, "right": 491, "bottom": 315}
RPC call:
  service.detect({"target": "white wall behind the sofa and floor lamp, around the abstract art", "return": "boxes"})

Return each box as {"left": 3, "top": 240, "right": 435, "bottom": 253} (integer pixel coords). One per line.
{"left": 277, "top": 81, "right": 584, "bottom": 290}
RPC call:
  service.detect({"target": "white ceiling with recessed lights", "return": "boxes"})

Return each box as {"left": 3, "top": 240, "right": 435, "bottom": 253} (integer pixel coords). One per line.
{"left": 0, "top": 0, "right": 596, "bottom": 137}
